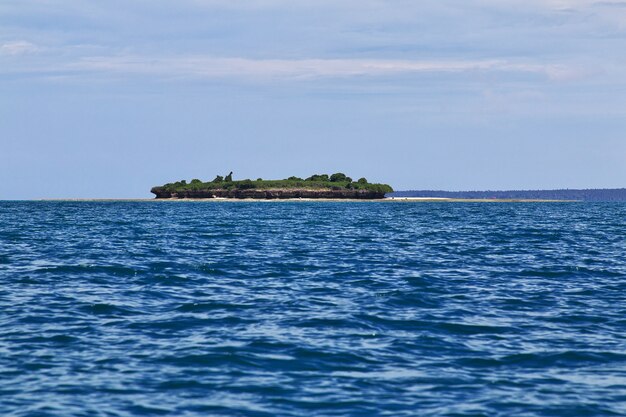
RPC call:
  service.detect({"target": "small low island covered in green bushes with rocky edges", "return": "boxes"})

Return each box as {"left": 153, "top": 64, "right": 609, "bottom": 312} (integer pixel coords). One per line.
{"left": 150, "top": 172, "right": 393, "bottom": 200}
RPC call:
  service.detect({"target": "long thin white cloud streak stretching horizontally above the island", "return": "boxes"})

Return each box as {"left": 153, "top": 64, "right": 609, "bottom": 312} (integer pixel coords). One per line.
{"left": 70, "top": 56, "right": 576, "bottom": 79}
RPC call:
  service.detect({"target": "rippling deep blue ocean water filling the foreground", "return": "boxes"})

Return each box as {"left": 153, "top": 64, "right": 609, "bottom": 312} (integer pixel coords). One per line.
{"left": 0, "top": 202, "right": 626, "bottom": 417}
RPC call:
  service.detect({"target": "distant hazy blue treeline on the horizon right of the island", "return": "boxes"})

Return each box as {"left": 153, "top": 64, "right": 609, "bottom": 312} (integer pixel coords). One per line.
{"left": 387, "top": 188, "right": 626, "bottom": 201}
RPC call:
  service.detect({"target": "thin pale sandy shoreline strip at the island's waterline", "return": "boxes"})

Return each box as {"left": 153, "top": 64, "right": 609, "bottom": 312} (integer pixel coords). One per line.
{"left": 31, "top": 197, "right": 577, "bottom": 203}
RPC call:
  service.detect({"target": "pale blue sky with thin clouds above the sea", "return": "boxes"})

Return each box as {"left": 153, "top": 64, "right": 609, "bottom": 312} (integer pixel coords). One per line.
{"left": 0, "top": 0, "right": 626, "bottom": 199}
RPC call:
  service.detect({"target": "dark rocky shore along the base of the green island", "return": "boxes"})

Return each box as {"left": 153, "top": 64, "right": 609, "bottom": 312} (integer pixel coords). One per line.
{"left": 150, "top": 187, "right": 385, "bottom": 200}
